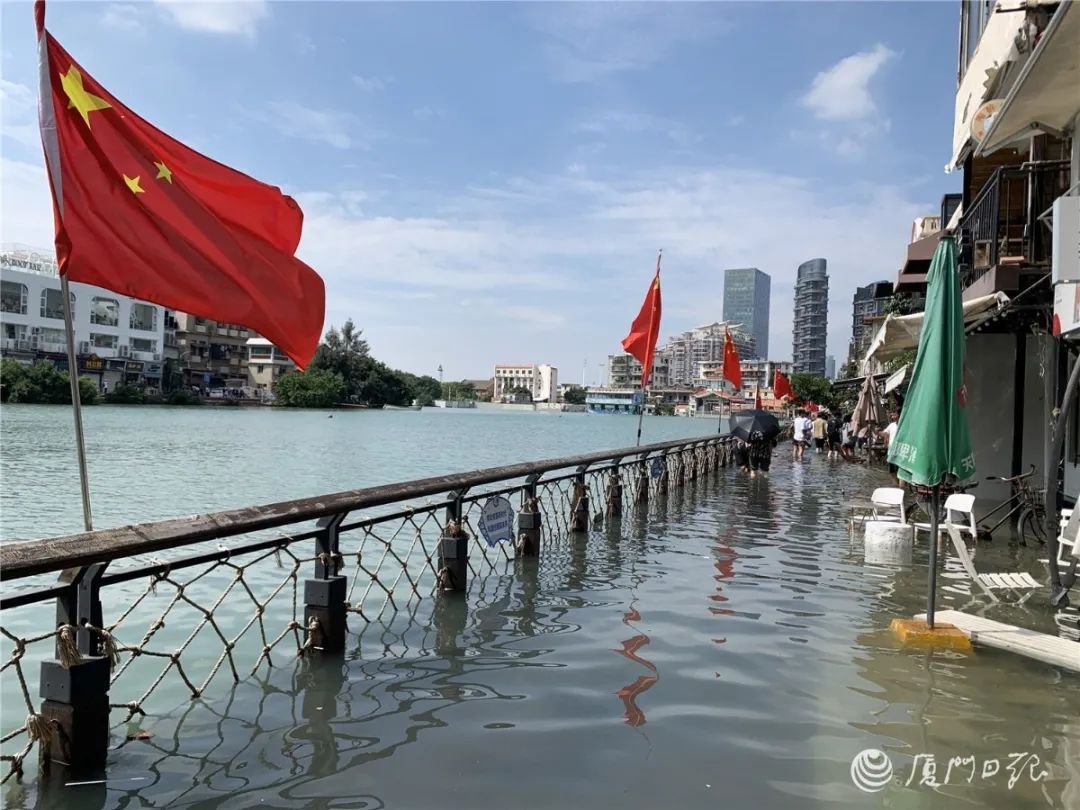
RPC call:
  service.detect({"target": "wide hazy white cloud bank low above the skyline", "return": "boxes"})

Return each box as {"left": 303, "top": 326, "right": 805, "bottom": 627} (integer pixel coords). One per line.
{"left": 0, "top": 147, "right": 932, "bottom": 378}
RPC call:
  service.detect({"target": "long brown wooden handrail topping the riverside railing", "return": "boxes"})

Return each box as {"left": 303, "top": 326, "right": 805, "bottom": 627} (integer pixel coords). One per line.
{"left": 0, "top": 435, "right": 726, "bottom": 581}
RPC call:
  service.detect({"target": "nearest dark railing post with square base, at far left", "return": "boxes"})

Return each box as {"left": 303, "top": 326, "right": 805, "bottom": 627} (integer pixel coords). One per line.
{"left": 39, "top": 563, "right": 111, "bottom": 778}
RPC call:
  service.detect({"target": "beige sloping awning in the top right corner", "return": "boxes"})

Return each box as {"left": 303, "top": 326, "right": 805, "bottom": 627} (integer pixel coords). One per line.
{"left": 975, "top": 2, "right": 1080, "bottom": 156}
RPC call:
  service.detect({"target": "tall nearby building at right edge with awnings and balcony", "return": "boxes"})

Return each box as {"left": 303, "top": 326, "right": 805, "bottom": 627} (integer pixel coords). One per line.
{"left": 864, "top": 0, "right": 1080, "bottom": 507}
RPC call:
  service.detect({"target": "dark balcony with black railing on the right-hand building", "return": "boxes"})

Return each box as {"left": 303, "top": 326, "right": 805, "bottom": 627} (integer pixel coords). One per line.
{"left": 957, "top": 161, "right": 1069, "bottom": 300}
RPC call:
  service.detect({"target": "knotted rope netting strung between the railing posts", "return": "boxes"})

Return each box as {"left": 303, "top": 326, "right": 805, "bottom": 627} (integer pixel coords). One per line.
{"left": 0, "top": 444, "right": 727, "bottom": 782}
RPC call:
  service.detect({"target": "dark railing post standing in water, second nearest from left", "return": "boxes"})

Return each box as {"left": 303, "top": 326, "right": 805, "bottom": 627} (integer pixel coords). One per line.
{"left": 303, "top": 512, "right": 349, "bottom": 653}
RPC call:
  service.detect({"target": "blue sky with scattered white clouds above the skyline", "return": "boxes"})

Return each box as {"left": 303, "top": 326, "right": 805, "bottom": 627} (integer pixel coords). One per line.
{"left": 0, "top": 0, "right": 959, "bottom": 380}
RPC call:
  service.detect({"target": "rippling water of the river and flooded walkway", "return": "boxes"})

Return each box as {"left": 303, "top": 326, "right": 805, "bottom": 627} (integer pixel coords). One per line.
{"left": 0, "top": 407, "right": 1080, "bottom": 810}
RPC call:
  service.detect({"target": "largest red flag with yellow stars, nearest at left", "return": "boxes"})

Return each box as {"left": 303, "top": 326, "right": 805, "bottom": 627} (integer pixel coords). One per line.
{"left": 33, "top": 0, "right": 326, "bottom": 367}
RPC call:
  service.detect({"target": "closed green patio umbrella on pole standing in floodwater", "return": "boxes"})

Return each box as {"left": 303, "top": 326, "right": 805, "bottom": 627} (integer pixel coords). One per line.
{"left": 889, "top": 237, "right": 975, "bottom": 627}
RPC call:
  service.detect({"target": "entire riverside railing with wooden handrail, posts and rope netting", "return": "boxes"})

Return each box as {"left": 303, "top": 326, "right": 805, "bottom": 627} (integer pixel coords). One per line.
{"left": 0, "top": 435, "right": 730, "bottom": 781}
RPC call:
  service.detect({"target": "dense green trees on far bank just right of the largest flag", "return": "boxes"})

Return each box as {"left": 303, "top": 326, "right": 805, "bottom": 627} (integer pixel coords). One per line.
{"left": 274, "top": 319, "right": 462, "bottom": 408}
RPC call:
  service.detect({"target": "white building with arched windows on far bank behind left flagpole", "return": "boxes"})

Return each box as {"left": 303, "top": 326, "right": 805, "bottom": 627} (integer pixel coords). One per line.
{"left": 0, "top": 245, "right": 165, "bottom": 388}
